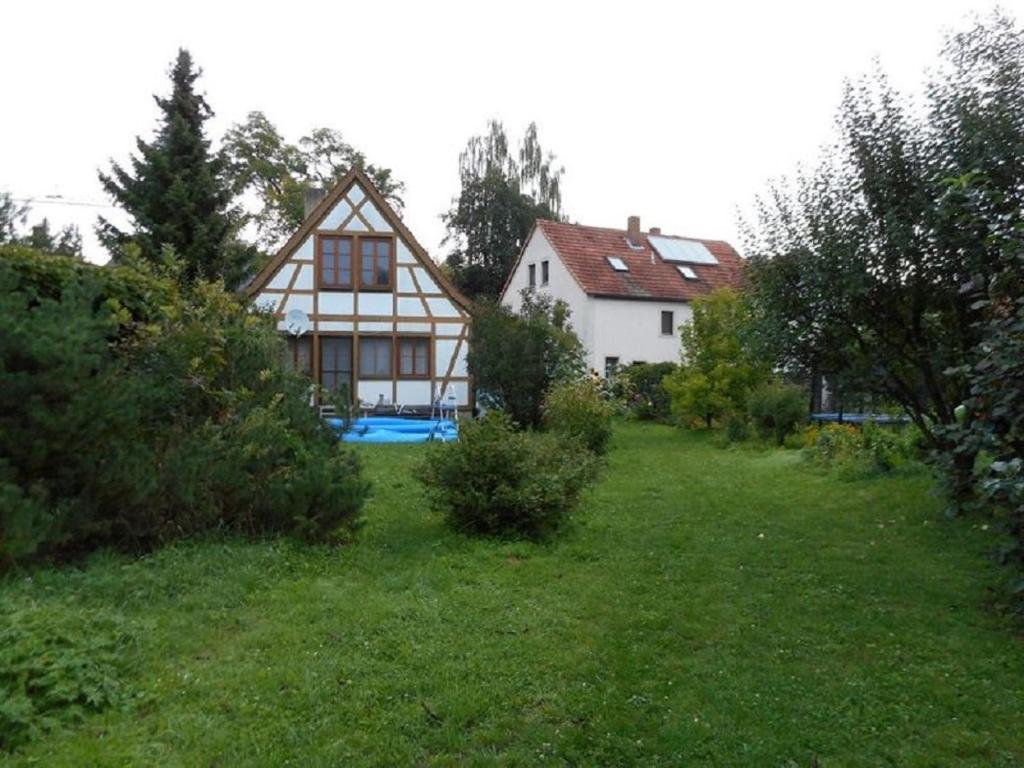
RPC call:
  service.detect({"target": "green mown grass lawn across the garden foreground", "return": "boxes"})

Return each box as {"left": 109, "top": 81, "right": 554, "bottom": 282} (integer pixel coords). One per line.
{"left": 0, "top": 425, "right": 1024, "bottom": 767}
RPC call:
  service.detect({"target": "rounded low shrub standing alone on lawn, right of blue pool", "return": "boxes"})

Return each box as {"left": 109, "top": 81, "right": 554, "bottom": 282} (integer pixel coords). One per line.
{"left": 417, "top": 411, "right": 596, "bottom": 538}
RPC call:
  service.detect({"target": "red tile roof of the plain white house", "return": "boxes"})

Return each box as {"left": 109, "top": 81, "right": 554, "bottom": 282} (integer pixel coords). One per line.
{"left": 537, "top": 219, "right": 743, "bottom": 301}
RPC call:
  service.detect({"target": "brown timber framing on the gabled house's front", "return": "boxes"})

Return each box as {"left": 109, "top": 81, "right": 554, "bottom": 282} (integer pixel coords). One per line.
{"left": 247, "top": 170, "right": 475, "bottom": 408}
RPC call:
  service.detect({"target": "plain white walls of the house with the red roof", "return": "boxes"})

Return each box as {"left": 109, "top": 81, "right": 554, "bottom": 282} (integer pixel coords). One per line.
{"left": 502, "top": 229, "right": 693, "bottom": 374}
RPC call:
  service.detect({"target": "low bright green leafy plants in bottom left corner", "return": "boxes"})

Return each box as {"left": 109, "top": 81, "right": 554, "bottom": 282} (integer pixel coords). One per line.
{"left": 0, "top": 604, "right": 133, "bottom": 751}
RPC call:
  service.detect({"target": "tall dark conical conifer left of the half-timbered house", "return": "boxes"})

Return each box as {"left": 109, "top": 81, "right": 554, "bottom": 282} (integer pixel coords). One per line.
{"left": 97, "top": 49, "right": 245, "bottom": 287}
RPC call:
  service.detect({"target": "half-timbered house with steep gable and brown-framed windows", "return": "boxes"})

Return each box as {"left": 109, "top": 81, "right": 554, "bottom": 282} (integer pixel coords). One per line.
{"left": 248, "top": 165, "right": 472, "bottom": 409}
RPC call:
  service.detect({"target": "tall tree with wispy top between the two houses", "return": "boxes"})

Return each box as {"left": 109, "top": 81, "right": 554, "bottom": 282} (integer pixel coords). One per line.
{"left": 442, "top": 120, "right": 564, "bottom": 299}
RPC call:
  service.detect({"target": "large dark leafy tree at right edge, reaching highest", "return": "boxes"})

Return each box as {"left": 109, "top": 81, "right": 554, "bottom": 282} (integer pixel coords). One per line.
{"left": 748, "top": 13, "right": 1024, "bottom": 499}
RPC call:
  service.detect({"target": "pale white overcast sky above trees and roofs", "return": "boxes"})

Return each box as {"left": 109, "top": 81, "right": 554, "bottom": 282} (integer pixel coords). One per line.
{"left": 0, "top": 0, "right": 1024, "bottom": 261}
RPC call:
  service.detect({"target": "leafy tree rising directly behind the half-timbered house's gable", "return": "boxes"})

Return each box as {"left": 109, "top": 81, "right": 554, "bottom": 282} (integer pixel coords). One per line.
{"left": 224, "top": 112, "right": 406, "bottom": 250}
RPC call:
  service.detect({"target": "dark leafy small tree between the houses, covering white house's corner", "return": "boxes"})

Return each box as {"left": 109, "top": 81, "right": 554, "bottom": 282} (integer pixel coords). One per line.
{"left": 468, "top": 291, "right": 586, "bottom": 427}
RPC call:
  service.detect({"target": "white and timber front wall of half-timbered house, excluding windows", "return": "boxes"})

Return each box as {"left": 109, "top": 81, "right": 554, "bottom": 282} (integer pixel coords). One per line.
{"left": 254, "top": 180, "right": 472, "bottom": 408}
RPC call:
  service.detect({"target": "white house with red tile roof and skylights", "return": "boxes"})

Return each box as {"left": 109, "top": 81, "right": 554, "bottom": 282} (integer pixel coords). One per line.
{"left": 502, "top": 216, "right": 743, "bottom": 373}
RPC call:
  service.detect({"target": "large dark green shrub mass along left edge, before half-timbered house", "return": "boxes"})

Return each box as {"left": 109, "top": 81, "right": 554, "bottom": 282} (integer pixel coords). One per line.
{"left": 0, "top": 244, "right": 367, "bottom": 566}
